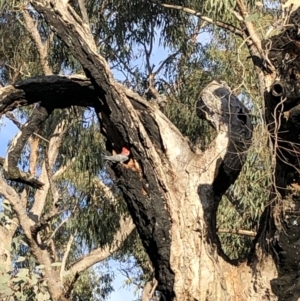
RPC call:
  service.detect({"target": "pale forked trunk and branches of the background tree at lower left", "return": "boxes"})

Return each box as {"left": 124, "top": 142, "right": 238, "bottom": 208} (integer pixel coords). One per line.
{"left": 0, "top": 148, "right": 135, "bottom": 301}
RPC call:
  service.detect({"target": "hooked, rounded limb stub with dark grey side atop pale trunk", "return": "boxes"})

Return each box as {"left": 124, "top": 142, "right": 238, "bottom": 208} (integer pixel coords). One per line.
{"left": 197, "top": 81, "right": 252, "bottom": 196}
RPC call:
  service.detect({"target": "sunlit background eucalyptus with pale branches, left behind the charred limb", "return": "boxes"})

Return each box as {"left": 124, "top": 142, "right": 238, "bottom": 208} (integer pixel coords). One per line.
{"left": 0, "top": 2, "right": 135, "bottom": 300}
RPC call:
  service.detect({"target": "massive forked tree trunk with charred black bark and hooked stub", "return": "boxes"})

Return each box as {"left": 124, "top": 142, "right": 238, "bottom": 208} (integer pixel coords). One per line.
{"left": 0, "top": 1, "right": 300, "bottom": 301}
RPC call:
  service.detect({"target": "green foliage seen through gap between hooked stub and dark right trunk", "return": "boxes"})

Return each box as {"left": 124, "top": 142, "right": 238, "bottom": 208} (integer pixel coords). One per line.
{"left": 217, "top": 125, "right": 272, "bottom": 259}
